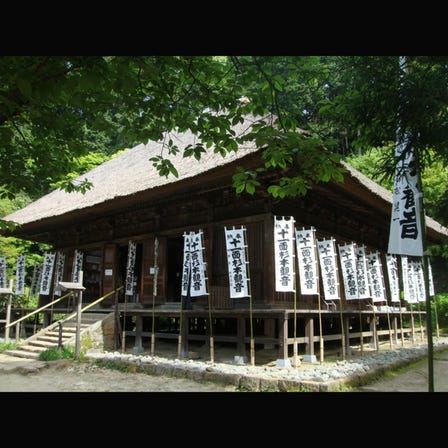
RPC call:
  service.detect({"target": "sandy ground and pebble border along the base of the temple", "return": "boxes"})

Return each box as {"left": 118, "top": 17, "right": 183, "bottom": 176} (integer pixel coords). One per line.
{"left": 0, "top": 337, "right": 448, "bottom": 392}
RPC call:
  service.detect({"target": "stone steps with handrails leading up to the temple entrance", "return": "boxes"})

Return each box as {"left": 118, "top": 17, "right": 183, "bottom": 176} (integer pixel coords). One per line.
{"left": 4, "top": 312, "right": 108, "bottom": 359}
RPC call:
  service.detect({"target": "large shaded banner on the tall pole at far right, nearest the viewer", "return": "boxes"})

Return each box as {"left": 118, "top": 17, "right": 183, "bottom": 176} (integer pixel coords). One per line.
{"left": 388, "top": 135, "right": 423, "bottom": 257}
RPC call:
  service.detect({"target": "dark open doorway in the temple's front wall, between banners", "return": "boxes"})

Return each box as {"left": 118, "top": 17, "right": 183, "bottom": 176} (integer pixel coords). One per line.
{"left": 166, "top": 237, "right": 184, "bottom": 302}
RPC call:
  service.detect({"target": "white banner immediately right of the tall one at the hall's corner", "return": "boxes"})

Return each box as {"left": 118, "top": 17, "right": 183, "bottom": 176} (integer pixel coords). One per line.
{"left": 296, "top": 228, "right": 319, "bottom": 295}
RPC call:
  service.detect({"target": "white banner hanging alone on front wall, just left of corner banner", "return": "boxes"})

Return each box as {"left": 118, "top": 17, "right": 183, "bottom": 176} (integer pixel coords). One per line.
{"left": 224, "top": 226, "right": 249, "bottom": 299}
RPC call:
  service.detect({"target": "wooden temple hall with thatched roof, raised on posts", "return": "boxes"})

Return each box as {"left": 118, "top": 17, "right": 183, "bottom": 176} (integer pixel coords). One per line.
{"left": 0, "top": 117, "right": 448, "bottom": 365}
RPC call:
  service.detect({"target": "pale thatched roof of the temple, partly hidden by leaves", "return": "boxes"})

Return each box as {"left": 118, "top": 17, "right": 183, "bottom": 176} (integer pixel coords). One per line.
{"left": 3, "top": 117, "right": 448, "bottom": 240}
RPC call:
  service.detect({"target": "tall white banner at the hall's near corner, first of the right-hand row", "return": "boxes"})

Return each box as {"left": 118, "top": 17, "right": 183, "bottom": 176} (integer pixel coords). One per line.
{"left": 274, "top": 216, "right": 295, "bottom": 292}
